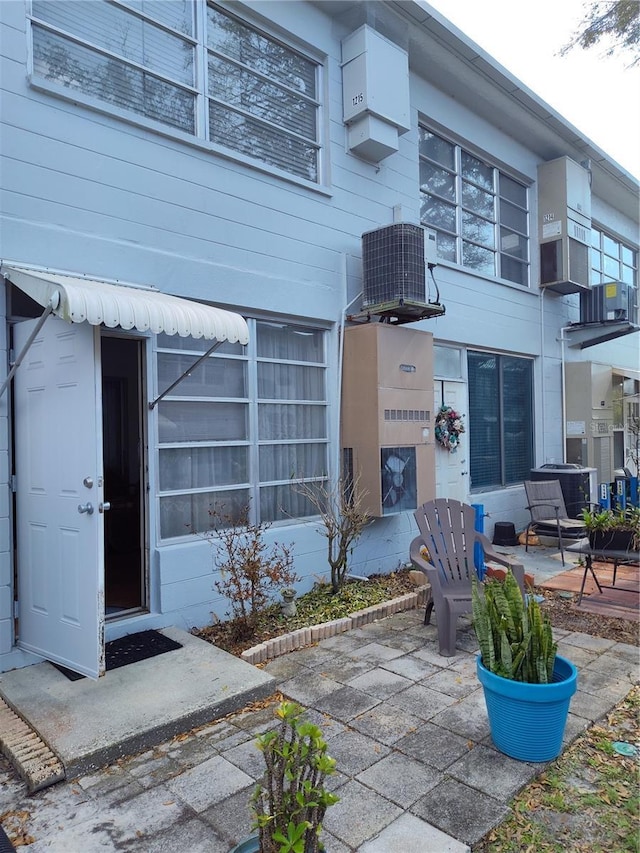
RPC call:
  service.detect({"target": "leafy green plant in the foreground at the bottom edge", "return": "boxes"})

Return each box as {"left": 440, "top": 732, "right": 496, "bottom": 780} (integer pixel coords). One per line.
{"left": 232, "top": 701, "right": 339, "bottom": 853}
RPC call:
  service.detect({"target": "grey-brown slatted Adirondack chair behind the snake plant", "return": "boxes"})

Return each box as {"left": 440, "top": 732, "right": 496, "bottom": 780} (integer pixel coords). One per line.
{"left": 409, "top": 498, "right": 524, "bottom": 657}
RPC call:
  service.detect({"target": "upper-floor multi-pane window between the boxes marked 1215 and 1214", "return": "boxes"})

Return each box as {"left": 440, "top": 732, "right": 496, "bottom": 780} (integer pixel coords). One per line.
{"left": 420, "top": 127, "right": 529, "bottom": 286}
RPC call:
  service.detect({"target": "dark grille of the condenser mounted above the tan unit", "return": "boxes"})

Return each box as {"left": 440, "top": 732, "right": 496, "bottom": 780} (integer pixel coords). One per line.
{"left": 362, "top": 222, "right": 426, "bottom": 307}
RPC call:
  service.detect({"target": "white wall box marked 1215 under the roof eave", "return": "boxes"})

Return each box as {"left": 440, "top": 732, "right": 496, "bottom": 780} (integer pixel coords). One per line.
{"left": 342, "top": 24, "right": 411, "bottom": 163}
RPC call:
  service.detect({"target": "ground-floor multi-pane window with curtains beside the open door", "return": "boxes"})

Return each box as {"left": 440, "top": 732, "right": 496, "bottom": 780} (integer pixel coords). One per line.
{"left": 157, "top": 321, "right": 328, "bottom": 539}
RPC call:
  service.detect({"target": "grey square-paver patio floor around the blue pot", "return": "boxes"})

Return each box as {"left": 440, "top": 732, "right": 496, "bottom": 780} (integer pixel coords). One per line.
{"left": 0, "top": 549, "right": 638, "bottom": 853}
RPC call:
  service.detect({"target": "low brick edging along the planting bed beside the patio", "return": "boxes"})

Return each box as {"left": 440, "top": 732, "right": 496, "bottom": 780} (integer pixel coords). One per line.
{"left": 241, "top": 585, "right": 431, "bottom": 664}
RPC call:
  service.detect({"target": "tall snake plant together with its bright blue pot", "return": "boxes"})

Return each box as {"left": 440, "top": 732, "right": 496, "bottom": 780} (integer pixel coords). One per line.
{"left": 472, "top": 570, "right": 578, "bottom": 761}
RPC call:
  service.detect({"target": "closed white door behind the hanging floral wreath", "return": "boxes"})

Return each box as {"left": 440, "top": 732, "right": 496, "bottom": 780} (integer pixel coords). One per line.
{"left": 434, "top": 381, "right": 469, "bottom": 503}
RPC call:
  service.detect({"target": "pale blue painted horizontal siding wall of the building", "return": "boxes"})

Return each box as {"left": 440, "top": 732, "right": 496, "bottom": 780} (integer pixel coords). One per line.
{"left": 0, "top": 0, "right": 630, "bottom": 669}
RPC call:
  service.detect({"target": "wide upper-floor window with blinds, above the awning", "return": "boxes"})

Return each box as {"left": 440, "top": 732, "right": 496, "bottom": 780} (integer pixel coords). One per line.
{"left": 31, "top": 0, "right": 320, "bottom": 182}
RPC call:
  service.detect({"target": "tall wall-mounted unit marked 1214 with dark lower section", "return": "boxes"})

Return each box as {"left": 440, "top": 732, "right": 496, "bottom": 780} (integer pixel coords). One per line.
{"left": 538, "top": 157, "right": 591, "bottom": 294}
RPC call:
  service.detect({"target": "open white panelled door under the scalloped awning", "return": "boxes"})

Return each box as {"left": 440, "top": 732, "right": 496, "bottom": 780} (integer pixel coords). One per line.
{"left": 14, "top": 317, "right": 104, "bottom": 678}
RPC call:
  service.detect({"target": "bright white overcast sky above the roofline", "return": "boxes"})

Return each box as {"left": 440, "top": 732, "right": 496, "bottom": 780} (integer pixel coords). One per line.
{"left": 427, "top": 0, "right": 640, "bottom": 179}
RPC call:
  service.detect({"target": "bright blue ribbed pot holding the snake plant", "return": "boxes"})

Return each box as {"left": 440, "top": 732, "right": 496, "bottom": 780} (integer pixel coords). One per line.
{"left": 476, "top": 655, "right": 578, "bottom": 762}
